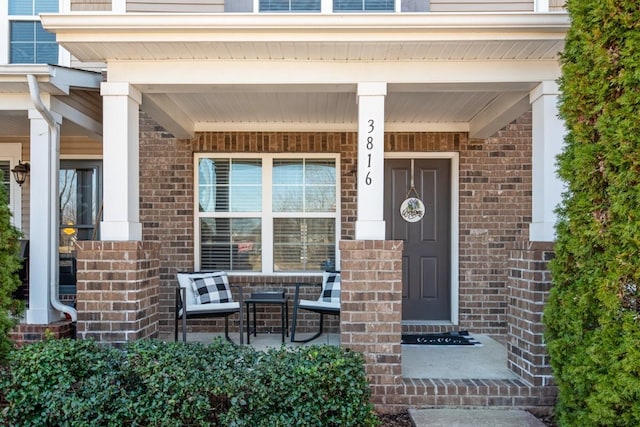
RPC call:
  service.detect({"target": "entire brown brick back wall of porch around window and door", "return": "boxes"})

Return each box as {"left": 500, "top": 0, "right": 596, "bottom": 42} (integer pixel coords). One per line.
{"left": 140, "top": 113, "right": 531, "bottom": 340}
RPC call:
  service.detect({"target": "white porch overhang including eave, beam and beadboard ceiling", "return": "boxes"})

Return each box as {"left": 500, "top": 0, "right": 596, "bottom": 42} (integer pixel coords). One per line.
{"left": 42, "top": 13, "right": 569, "bottom": 138}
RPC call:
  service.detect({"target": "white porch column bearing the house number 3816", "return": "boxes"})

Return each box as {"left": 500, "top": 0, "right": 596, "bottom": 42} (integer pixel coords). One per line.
{"left": 356, "top": 83, "right": 387, "bottom": 240}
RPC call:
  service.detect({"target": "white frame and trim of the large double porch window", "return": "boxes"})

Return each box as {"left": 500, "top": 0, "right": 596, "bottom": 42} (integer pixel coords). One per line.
{"left": 193, "top": 153, "right": 342, "bottom": 276}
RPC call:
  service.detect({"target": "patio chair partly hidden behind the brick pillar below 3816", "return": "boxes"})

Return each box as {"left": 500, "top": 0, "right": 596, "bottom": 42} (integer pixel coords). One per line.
{"left": 291, "top": 271, "right": 340, "bottom": 342}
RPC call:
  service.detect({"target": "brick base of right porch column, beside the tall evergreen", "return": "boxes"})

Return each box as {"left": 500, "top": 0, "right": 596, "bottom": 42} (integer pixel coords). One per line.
{"left": 507, "top": 242, "right": 554, "bottom": 386}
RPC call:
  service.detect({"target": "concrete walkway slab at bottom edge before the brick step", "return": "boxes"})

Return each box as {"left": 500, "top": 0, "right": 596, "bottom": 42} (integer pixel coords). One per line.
{"left": 409, "top": 409, "right": 545, "bottom": 427}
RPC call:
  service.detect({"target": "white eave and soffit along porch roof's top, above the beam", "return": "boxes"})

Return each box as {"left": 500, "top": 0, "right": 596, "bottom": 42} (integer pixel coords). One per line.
{"left": 41, "top": 13, "right": 569, "bottom": 62}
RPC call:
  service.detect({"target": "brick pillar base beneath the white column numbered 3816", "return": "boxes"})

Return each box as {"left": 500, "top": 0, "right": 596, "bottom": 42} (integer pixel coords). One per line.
{"left": 340, "top": 240, "right": 404, "bottom": 412}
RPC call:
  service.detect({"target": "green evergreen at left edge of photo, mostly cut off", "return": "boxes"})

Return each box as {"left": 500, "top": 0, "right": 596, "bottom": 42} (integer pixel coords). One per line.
{"left": 0, "top": 171, "right": 24, "bottom": 362}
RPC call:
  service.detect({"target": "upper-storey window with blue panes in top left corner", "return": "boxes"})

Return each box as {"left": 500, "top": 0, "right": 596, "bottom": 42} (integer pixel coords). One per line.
{"left": 9, "top": 0, "right": 58, "bottom": 64}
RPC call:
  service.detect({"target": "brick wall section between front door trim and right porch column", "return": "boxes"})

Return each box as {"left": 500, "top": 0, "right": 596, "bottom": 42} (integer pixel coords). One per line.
{"left": 460, "top": 114, "right": 531, "bottom": 334}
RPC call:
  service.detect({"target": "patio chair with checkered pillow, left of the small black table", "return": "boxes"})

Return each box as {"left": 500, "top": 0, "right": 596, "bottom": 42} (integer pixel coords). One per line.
{"left": 174, "top": 271, "right": 244, "bottom": 344}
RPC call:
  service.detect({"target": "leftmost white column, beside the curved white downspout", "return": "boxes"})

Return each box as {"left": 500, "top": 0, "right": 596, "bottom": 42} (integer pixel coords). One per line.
{"left": 27, "top": 110, "right": 61, "bottom": 325}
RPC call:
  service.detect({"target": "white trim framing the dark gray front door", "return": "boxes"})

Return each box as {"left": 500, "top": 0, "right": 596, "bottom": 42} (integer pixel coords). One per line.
{"left": 384, "top": 151, "right": 460, "bottom": 325}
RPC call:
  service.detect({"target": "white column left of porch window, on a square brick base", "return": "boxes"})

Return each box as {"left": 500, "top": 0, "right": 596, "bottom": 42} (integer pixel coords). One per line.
{"left": 100, "top": 82, "right": 142, "bottom": 241}
